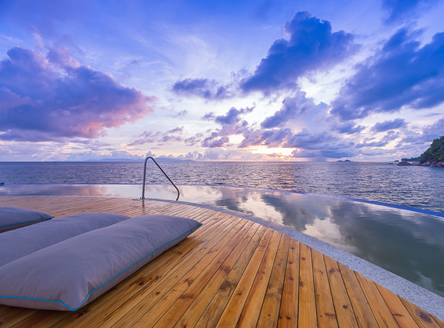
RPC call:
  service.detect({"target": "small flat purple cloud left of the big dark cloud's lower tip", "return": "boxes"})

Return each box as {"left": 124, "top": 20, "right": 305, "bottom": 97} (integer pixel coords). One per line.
{"left": 172, "top": 79, "right": 233, "bottom": 100}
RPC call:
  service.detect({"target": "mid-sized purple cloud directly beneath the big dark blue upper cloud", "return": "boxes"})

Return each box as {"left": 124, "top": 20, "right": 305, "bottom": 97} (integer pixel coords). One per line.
{"left": 261, "top": 91, "right": 315, "bottom": 129}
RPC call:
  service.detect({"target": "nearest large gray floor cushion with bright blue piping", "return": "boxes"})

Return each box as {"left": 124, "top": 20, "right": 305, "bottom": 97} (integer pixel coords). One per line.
{"left": 0, "top": 215, "right": 201, "bottom": 311}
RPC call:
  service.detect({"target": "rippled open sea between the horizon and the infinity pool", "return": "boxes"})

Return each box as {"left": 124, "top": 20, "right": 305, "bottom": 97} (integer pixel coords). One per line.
{"left": 0, "top": 162, "right": 444, "bottom": 212}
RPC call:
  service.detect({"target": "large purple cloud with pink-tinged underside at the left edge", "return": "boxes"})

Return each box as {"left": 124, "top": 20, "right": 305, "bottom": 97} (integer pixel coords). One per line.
{"left": 0, "top": 47, "right": 156, "bottom": 141}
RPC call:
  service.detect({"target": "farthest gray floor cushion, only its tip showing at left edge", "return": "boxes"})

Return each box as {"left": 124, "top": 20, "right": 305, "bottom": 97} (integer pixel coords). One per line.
{"left": 0, "top": 207, "right": 53, "bottom": 232}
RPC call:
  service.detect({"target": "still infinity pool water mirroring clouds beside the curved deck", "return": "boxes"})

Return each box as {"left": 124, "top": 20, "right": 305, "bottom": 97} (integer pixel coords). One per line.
{"left": 0, "top": 185, "right": 444, "bottom": 296}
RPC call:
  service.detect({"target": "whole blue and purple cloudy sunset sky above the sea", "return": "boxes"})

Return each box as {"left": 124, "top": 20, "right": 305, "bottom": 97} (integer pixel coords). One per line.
{"left": 0, "top": 0, "right": 444, "bottom": 161}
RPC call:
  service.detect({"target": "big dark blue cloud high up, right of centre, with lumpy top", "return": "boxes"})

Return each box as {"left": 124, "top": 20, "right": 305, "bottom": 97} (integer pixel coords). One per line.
{"left": 240, "top": 12, "right": 357, "bottom": 95}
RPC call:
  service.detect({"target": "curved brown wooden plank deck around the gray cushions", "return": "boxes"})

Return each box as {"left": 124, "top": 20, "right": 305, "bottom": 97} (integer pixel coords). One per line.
{"left": 0, "top": 197, "right": 444, "bottom": 328}
